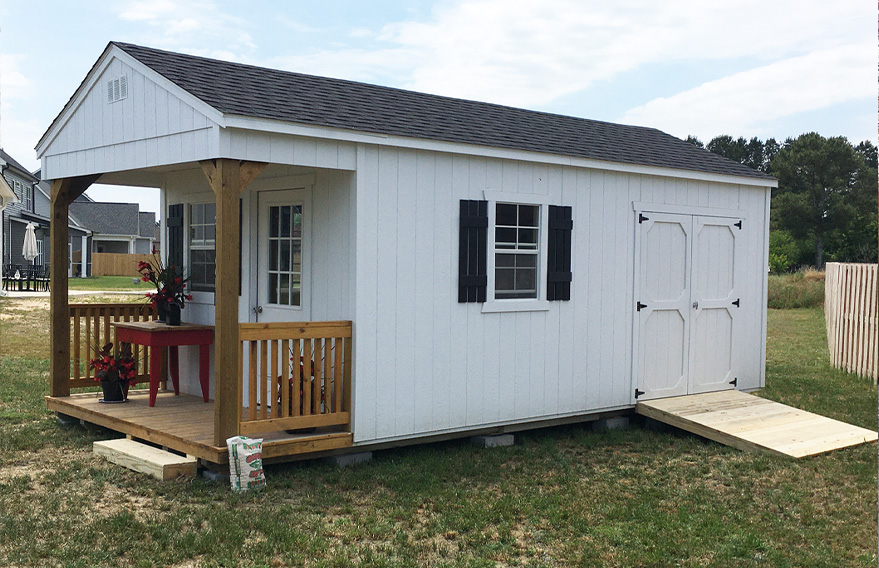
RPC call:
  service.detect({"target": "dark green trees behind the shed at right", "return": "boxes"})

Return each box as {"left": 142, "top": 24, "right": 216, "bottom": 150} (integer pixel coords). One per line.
{"left": 687, "top": 132, "right": 879, "bottom": 272}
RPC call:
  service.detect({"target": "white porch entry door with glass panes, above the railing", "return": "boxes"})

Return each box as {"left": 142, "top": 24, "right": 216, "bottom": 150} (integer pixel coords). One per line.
{"left": 254, "top": 189, "right": 311, "bottom": 322}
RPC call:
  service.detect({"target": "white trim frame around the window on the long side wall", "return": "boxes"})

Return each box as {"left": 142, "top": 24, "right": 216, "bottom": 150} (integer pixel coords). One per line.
{"left": 482, "top": 190, "right": 553, "bottom": 314}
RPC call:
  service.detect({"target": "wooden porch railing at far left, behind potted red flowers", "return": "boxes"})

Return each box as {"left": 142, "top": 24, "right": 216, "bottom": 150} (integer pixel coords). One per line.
{"left": 68, "top": 303, "right": 158, "bottom": 388}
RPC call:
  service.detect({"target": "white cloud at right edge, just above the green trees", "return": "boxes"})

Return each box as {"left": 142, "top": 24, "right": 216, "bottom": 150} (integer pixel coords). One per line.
{"left": 623, "top": 44, "right": 877, "bottom": 138}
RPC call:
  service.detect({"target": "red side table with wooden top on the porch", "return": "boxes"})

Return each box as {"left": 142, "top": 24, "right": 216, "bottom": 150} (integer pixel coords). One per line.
{"left": 112, "top": 321, "right": 214, "bottom": 406}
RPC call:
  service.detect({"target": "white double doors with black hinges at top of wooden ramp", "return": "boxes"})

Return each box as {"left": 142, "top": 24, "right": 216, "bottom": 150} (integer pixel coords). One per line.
{"left": 634, "top": 212, "right": 742, "bottom": 400}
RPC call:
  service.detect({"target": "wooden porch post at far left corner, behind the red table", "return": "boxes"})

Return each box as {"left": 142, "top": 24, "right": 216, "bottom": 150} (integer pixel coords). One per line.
{"left": 49, "top": 175, "right": 99, "bottom": 396}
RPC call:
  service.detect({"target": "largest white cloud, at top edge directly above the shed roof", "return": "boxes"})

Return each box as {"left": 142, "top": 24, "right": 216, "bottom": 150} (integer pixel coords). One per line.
{"left": 276, "top": 0, "right": 875, "bottom": 107}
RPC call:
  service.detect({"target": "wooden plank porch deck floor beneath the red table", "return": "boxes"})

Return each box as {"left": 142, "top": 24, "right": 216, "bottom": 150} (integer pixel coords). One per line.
{"left": 46, "top": 390, "right": 352, "bottom": 464}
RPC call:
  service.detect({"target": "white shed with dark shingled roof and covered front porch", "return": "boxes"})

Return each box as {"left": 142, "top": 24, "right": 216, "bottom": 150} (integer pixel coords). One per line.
{"left": 37, "top": 43, "right": 776, "bottom": 462}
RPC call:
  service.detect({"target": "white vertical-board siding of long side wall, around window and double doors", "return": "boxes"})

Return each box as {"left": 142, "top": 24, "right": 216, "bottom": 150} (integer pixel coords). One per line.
{"left": 354, "top": 145, "right": 768, "bottom": 443}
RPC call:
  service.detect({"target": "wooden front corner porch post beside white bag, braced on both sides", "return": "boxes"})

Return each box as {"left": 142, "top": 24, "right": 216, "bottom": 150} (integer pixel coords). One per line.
{"left": 201, "top": 158, "right": 266, "bottom": 446}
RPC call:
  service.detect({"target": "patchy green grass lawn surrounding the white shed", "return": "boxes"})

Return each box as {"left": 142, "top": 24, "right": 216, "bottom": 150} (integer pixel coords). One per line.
{"left": 0, "top": 299, "right": 877, "bottom": 567}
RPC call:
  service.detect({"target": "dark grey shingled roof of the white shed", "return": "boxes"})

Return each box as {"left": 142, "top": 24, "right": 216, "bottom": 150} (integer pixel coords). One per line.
{"left": 112, "top": 42, "right": 772, "bottom": 180}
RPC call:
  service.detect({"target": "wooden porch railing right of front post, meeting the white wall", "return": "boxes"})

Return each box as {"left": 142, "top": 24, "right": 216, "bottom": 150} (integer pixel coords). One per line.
{"left": 238, "top": 321, "right": 351, "bottom": 436}
